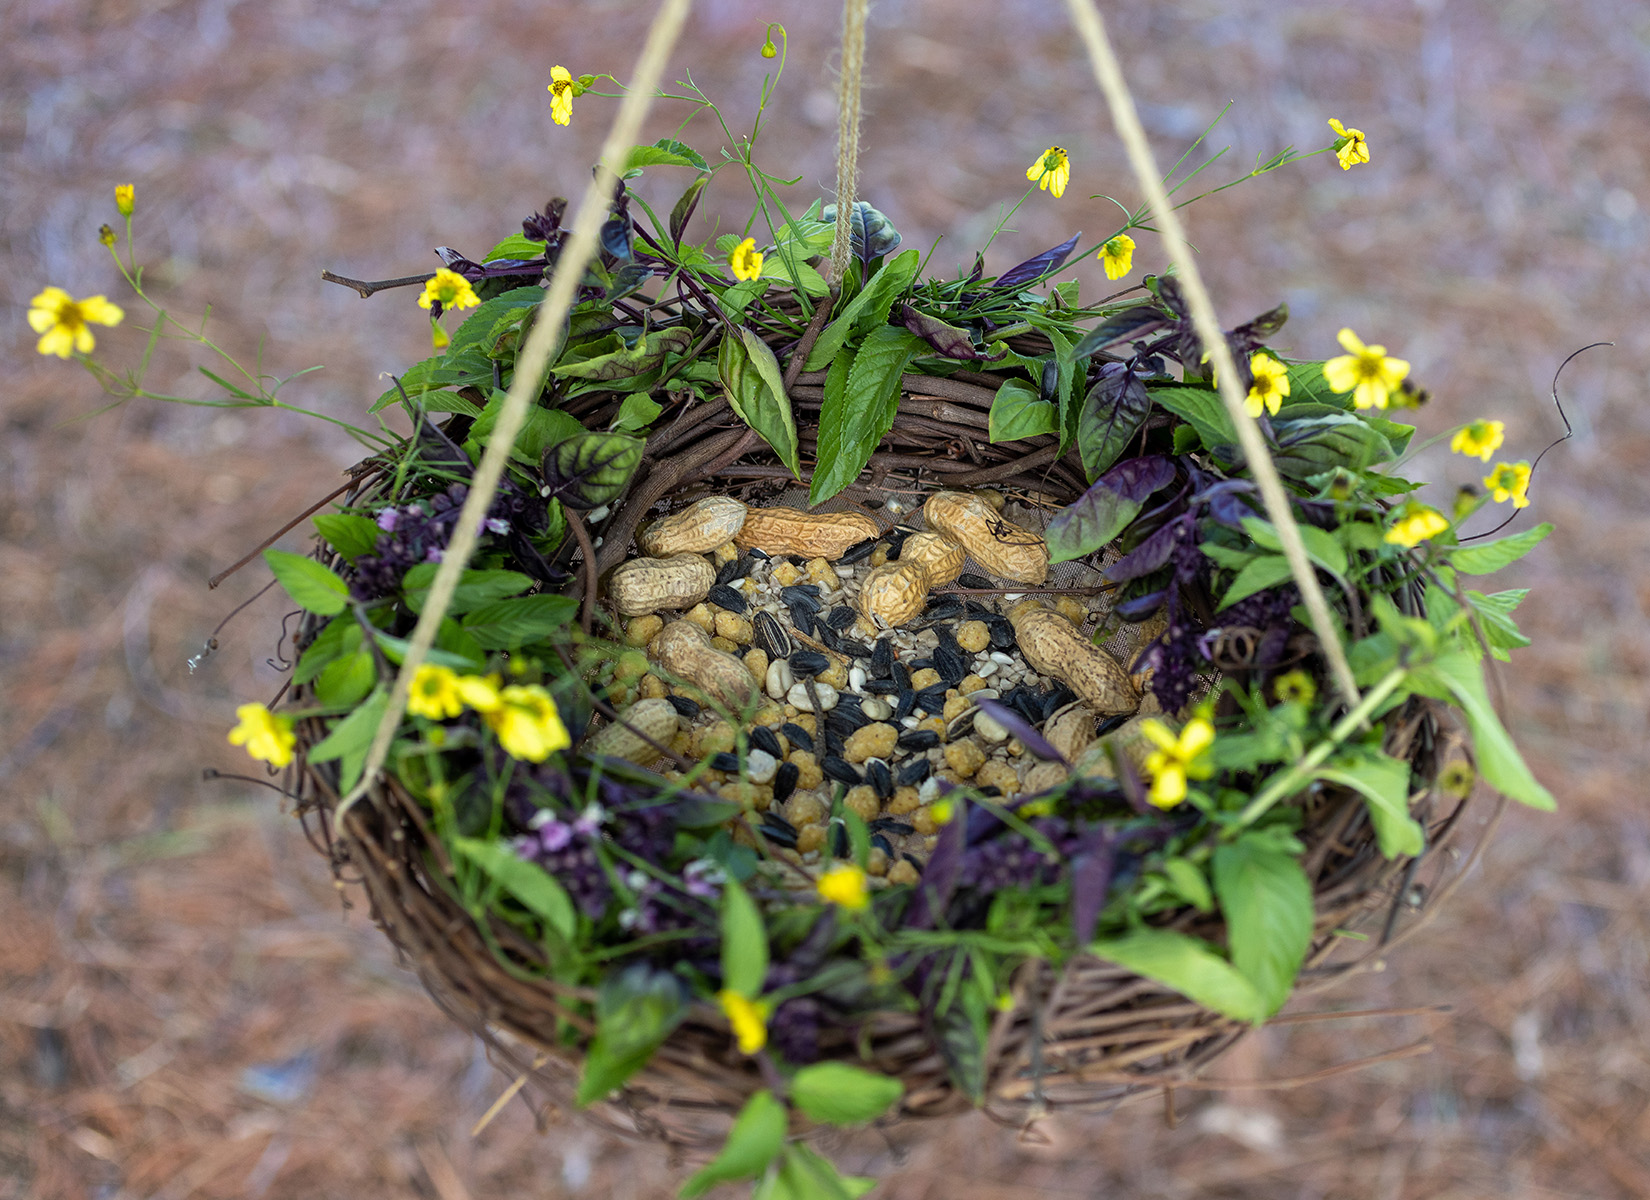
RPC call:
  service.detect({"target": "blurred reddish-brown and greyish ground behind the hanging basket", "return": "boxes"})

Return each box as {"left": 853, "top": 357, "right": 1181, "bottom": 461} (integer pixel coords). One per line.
{"left": 0, "top": 0, "right": 1650, "bottom": 1200}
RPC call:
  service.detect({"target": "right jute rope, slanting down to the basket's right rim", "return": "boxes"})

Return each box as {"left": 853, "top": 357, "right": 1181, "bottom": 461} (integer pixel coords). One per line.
{"left": 1066, "top": 0, "right": 1360, "bottom": 708}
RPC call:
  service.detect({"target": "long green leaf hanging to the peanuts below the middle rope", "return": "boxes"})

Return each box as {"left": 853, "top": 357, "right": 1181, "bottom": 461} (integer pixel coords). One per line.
{"left": 809, "top": 325, "right": 927, "bottom": 503}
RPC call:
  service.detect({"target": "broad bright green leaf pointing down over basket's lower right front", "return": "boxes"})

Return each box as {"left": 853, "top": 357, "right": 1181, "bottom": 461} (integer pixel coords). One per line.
{"left": 1214, "top": 837, "right": 1315, "bottom": 1017}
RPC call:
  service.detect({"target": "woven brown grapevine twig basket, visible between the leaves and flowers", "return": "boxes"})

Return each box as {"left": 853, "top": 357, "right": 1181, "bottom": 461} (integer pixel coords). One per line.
{"left": 277, "top": 300, "right": 1491, "bottom": 1152}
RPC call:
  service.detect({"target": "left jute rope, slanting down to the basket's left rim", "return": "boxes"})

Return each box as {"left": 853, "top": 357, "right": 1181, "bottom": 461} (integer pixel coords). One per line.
{"left": 337, "top": 0, "right": 691, "bottom": 820}
